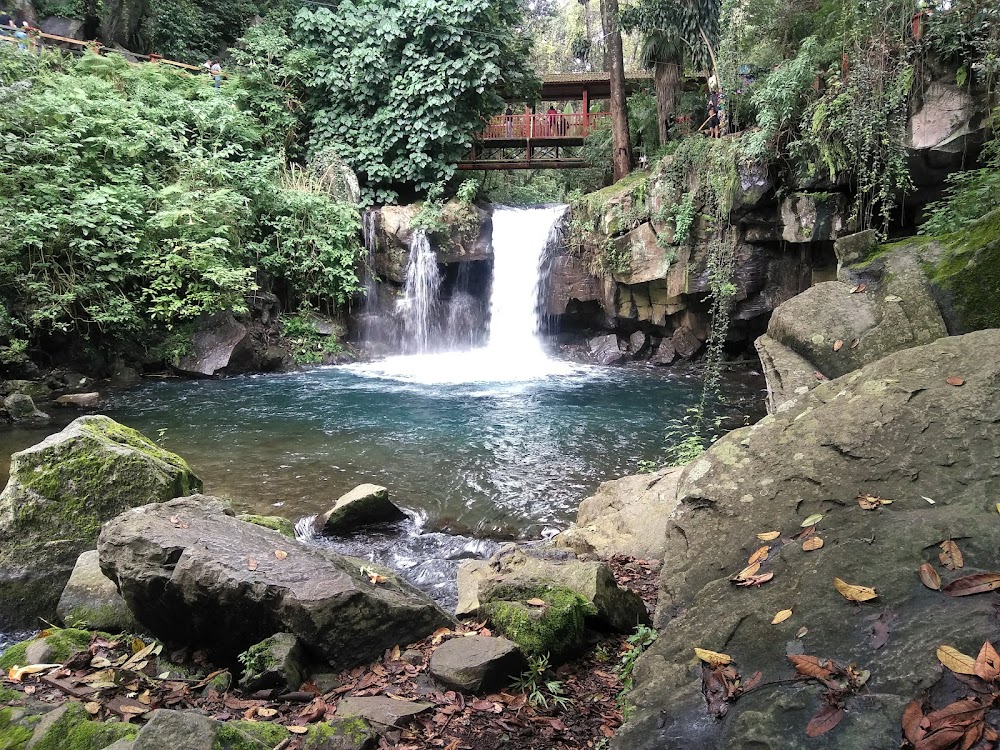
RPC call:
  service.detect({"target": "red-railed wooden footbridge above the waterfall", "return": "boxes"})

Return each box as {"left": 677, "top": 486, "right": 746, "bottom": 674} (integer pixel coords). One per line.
{"left": 458, "top": 73, "right": 653, "bottom": 170}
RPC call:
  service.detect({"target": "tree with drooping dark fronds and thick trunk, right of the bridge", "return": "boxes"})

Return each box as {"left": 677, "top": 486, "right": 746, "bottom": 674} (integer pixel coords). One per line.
{"left": 622, "top": 0, "right": 722, "bottom": 143}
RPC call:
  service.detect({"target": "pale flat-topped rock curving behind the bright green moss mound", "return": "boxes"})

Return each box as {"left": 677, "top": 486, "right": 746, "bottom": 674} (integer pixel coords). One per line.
{"left": 455, "top": 545, "right": 649, "bottom": 632}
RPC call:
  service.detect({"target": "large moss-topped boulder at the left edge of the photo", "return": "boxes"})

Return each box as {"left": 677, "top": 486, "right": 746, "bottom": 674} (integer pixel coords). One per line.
{"left": 0, "top": 415, "right": 202, "bottom": 626}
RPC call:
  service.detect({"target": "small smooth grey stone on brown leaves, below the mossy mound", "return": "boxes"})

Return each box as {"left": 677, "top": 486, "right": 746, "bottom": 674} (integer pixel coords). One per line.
{"left": 430, "top": 635, "right": 528, "bottom": 693}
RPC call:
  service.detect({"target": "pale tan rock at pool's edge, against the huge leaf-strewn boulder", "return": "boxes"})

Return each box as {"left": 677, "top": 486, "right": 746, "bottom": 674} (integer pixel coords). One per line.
{"left": 554, "top": 468, "right": 681, "bottom": 559}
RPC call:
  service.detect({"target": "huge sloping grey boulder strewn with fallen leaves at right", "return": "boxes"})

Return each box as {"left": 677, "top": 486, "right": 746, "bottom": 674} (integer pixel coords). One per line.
{"left": 612, "top": 330, "right": 1000, "bottom": 750}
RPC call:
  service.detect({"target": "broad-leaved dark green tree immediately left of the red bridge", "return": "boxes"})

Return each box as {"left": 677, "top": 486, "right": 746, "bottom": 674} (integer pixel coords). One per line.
{"left": 292, "top": 0, "right": 537, "bottom": 203}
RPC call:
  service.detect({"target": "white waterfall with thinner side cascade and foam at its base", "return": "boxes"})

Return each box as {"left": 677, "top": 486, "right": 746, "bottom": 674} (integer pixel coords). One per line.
{"left": 352, "top": 206, "right": 575, "bottom": 384}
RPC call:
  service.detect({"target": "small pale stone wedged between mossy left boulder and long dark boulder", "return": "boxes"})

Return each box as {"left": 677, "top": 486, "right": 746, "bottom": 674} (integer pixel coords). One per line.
{"left": 56, "top": 550, "right": 136, "bottom": 633}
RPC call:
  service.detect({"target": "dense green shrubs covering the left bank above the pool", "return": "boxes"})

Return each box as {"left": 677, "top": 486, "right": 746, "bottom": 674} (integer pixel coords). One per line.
{"left": 0, "top": 47, "right": 360, "bottom": 368}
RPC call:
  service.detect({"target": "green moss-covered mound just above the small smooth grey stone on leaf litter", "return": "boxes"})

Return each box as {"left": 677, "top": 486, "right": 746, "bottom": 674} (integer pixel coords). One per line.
{"left": 482, "top": 584, "right": 596, "bottom": 660}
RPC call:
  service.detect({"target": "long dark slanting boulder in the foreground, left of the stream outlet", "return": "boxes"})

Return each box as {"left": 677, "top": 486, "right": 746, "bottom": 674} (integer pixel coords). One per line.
{"left": 98, "top": 495, "right": 451, "bottom": 667}
